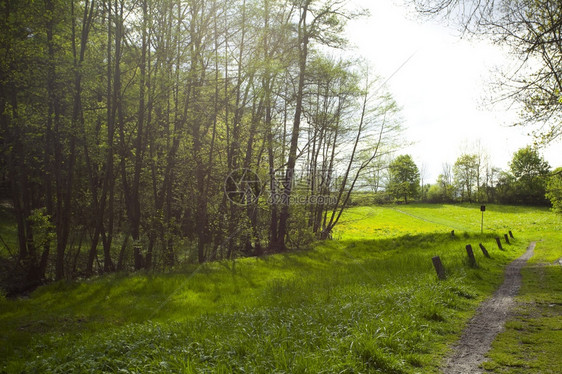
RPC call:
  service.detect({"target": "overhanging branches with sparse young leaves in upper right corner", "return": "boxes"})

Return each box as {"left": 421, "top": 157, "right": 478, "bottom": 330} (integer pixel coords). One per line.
{"left": 412, "top": 0, "right": 562, "bottom": 143}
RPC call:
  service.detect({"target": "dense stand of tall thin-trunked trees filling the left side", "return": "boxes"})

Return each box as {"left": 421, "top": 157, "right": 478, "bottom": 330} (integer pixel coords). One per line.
{"left": 0, "top": 0, "right": 398, "bottom": 289}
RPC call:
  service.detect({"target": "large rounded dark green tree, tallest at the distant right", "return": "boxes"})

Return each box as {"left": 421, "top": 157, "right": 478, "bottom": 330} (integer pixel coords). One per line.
{"left": 509, "top": 147, "right": 550, "bottom": 205}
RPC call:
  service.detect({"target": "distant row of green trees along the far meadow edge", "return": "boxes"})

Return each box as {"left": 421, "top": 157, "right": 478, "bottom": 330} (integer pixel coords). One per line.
{"left": 363, "top": 147, "right": 562, "bottom": 207}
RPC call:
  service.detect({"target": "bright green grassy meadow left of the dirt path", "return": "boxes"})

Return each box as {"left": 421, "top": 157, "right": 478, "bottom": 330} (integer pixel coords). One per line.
{"left": 0, "top": 205, "right": 562, "bottom": 373}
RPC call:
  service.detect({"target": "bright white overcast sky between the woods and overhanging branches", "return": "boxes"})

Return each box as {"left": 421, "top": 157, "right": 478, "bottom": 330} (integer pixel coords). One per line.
{"left": 348, "top": 0, "right": 562, "bottom": 183}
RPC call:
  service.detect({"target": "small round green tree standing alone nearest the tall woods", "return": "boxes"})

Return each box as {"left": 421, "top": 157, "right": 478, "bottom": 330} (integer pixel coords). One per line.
{"left": 387, "top": 155, "right": 420, "bottom": 204}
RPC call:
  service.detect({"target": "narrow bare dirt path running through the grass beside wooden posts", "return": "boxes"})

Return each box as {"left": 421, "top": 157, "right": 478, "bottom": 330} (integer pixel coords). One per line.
{"left": 442, "top": 242, "right": 536, "bottom": 374}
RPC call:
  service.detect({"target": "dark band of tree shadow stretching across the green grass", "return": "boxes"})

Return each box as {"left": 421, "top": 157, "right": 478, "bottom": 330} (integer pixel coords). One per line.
{"left": 0, "top": 229, "right": 521, "bottom": 364}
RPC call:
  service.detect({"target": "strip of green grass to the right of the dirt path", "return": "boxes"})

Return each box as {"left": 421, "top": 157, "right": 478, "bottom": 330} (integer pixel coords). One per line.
{"left": 476, "top": 232, "right": 562, "bottom": 373}
